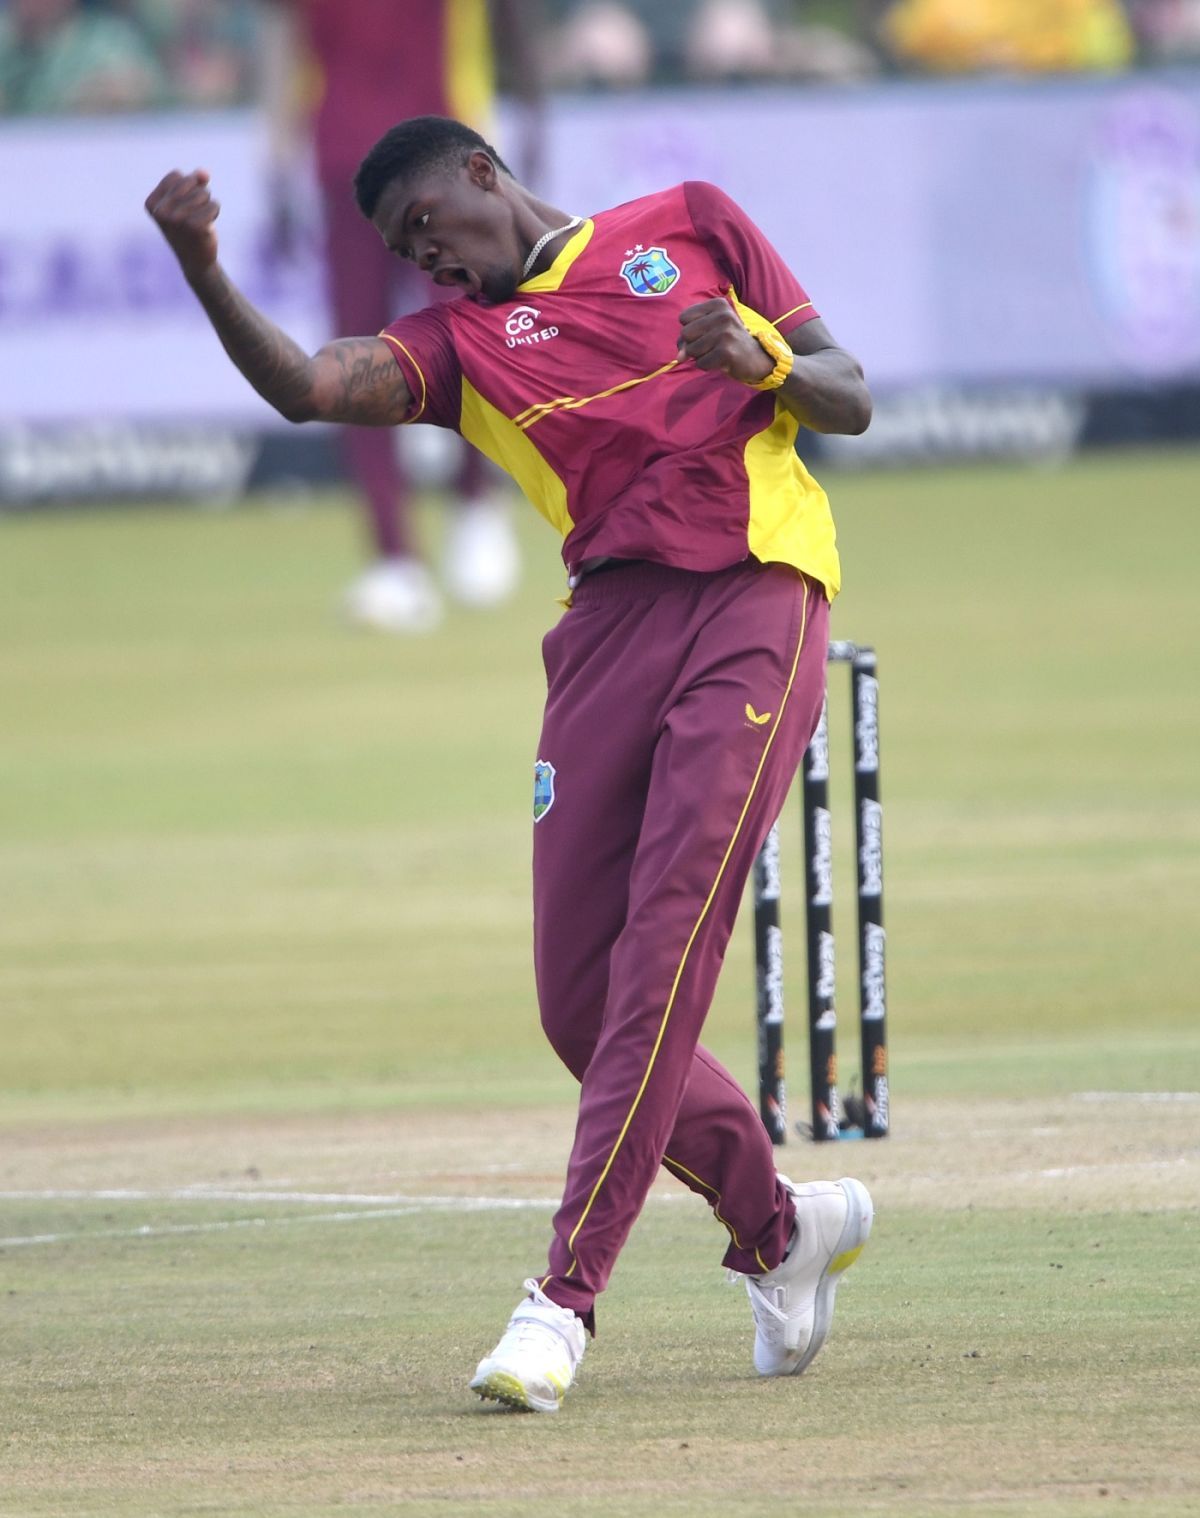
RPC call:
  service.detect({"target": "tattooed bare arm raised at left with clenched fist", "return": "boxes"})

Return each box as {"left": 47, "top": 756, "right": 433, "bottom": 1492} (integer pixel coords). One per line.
{"left": 146, "top": 168, "right": 413, "bottom": 427}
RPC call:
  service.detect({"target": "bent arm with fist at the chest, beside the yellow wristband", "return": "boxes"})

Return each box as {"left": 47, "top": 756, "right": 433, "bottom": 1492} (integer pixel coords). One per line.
{"left": 680, "top": 299, "right": 871, "bottom": 433}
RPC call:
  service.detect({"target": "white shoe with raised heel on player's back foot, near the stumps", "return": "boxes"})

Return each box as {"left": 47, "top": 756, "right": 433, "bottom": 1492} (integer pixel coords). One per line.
{"left": 746, "top": 1175, "right": 874, "bottom": 1375}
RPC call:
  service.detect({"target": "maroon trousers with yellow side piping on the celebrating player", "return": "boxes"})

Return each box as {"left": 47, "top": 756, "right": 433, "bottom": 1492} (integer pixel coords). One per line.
{"left": 534, "top": 560, "right": 828, "bottom": 1328}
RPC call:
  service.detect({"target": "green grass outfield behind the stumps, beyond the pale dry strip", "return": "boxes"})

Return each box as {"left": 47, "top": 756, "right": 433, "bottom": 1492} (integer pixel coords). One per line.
{"left": 0, "top": 454, "right": 1200, "bottom": 1116}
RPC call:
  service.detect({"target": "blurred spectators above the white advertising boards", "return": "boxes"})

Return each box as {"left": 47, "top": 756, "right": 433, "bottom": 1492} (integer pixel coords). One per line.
{"left": 0, "top": 0, "right": 1200, "bottom": 115}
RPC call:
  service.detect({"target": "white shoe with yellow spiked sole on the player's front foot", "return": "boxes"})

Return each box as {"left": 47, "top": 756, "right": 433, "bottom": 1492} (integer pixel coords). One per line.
{"left": 470, "top": 1281, "right": 587, "bottom": 1413}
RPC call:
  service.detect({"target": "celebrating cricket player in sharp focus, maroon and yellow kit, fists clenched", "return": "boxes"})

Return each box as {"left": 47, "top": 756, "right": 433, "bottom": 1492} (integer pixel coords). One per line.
{"left": 146, "top": 117, "right": 872, "bottom": 1412}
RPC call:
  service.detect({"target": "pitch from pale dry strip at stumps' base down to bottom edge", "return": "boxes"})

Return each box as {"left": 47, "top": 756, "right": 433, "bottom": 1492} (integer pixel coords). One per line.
{"left": 0, "top": 1093, "right": 1200, "bottom": 1518}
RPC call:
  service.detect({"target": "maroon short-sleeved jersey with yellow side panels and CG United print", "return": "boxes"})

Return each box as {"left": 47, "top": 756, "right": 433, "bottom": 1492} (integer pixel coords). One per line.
{"left": 382, "top": 182, "right": 839, "bottom": 595}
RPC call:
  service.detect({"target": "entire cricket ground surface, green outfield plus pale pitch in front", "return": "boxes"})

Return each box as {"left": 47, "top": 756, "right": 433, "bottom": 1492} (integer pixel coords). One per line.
{"left": 0, "top": 454, "right": 1200, "bottom": 1518}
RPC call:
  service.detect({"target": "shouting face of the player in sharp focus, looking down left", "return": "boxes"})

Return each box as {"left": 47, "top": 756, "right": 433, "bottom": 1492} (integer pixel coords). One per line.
{"left": 372, "top": 153, "right": 520, "bottom": 304}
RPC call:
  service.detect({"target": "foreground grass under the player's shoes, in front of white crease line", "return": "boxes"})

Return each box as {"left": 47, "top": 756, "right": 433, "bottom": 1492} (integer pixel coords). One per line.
{"left": 0, "top": 1202, "right": 1200, "bottom": 1518}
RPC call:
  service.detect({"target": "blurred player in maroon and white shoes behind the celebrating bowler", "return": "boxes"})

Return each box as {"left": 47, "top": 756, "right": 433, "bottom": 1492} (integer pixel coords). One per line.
{"left": 262, "top": 0, "right": 542, "bottom": 633}
